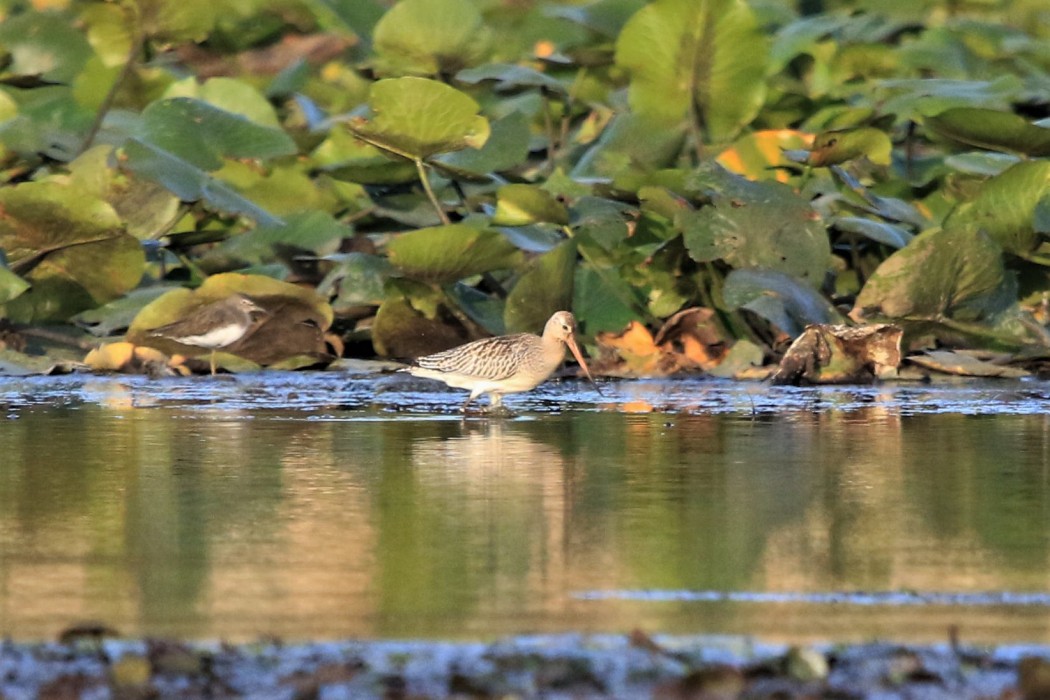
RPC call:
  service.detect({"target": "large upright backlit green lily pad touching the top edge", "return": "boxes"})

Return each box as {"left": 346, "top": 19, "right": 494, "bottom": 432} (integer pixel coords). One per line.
{"left": 616, "top": 0, "right": 769, "bottom": 142}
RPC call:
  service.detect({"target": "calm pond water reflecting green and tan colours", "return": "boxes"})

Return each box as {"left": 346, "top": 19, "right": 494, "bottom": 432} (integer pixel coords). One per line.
{"left": 0, "top": 374, "right": 1050, "bottom": 642}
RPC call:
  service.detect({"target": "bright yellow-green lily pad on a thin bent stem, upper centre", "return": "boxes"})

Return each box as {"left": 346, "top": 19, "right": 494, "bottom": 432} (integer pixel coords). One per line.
{"left": 348, "top": 77, "right": 489, "bottom": 161}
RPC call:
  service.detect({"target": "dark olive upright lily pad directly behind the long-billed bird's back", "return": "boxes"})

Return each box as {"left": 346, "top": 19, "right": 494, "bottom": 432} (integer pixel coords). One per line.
{"left": 503, "top": 240, "right": 576, "bottom": 333}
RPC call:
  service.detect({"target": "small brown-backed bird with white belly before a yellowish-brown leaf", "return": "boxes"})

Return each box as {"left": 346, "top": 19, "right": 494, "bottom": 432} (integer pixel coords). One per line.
{"left": 149, "top": 294, "right": 269, "bottom": 375}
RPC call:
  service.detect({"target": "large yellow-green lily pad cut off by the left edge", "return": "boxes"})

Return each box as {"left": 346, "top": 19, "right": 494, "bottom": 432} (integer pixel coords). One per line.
{"left": 0, "top": 182, "right": 146, "bottom": 322}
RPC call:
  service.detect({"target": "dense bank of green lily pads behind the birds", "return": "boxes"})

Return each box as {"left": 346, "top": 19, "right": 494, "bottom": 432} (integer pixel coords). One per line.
{"left": 0, "top": 0, "right": 1050, "bottom": 367}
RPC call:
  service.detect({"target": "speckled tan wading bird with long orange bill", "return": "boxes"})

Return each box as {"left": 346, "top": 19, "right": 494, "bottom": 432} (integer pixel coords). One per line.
{"left": 405, "top": 311, "right": 594, "bottom": 411}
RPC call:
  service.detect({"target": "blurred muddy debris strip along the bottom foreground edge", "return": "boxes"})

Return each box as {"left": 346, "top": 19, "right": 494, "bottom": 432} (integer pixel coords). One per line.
{"left": 0, "top": 632, "right": 1037, "bottom": 700}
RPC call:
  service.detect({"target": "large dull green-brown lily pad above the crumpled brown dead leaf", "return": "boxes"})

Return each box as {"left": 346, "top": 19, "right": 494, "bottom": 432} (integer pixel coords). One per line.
{"left": 851, "top": 228, "right": 1011, "bottom": 321}
